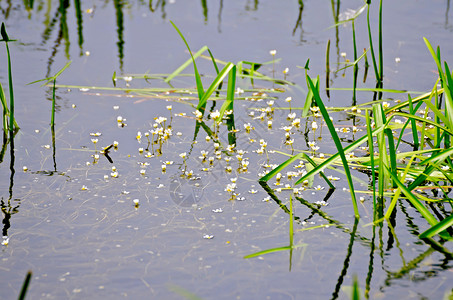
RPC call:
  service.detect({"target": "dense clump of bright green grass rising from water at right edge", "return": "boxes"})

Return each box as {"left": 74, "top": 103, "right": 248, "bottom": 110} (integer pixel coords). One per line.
{"left": 260, "top": 39, "right": 453, "bottom": 240}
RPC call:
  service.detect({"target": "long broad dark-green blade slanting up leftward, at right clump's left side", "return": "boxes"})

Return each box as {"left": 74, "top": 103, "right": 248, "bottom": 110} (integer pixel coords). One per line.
{"left": 307, "top": 76, "right": 360, "bottom": 218}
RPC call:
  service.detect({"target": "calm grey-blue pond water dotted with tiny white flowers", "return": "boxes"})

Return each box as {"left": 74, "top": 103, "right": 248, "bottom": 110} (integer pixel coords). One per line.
{"left": 0, "top": 0, "right": 453, "bottom": 299}
